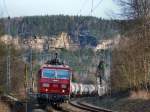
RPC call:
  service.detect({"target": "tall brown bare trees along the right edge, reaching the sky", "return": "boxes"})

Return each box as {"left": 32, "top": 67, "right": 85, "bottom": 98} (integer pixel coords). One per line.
{"left": 112, "top": 0, "right": 150, "bottom": 91}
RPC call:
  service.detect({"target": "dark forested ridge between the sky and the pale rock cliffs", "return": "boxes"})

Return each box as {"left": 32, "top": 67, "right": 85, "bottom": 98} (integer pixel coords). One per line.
{"left": 2, "top": 15, "right": 119, "bottom": 40}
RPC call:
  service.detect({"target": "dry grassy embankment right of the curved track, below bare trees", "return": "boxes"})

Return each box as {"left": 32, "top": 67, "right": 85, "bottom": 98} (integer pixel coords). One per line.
{"left": 85, "top": 92, "right": 150, "bottom": 112}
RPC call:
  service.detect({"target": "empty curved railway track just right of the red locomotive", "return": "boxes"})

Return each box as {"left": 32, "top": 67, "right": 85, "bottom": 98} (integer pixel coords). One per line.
{"left": 69, "top": 100, "right": 114, "bottom": 112}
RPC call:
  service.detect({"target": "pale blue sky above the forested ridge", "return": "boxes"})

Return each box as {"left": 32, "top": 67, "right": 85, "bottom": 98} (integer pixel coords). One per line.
{"left": 0, "top": 0, "right": 119, "bottom": 19}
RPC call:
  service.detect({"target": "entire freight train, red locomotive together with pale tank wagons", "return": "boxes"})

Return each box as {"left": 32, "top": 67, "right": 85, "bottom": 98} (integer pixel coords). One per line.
{"left": 37, "top": 55, "right": 105, "bottom": 105}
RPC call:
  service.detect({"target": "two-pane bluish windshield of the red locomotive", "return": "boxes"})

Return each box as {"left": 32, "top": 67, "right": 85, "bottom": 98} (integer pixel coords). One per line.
{"left": 42, "top": 69, "right": 70, "bottom": 79}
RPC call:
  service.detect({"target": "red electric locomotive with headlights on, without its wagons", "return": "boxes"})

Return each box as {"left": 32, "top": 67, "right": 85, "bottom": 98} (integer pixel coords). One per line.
{"left": 37, "top": 53, "right": 72, "bottom": 104}
